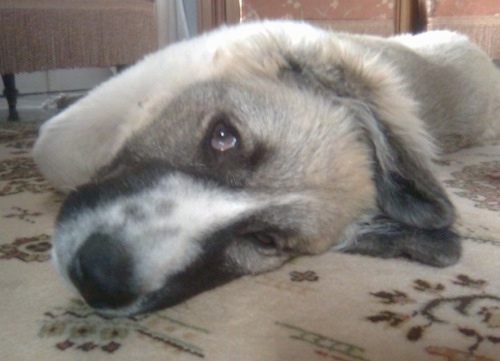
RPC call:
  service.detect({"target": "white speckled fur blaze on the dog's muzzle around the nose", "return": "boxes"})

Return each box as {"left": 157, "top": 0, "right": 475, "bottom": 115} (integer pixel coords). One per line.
{"left": 50, "top": 174, "right": 267, "bottom": 293}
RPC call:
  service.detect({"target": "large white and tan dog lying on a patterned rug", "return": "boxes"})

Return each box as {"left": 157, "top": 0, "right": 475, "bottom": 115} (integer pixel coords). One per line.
{"left": 34, "top": 21, "right": 500, "bottom": 315}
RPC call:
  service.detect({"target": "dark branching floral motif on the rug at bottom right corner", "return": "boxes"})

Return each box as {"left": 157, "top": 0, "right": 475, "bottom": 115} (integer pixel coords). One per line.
{"left": 367, "top": 274, "right": 500, "bottom": 360}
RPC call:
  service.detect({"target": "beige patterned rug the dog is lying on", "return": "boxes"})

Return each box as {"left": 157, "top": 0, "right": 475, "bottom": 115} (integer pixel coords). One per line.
{"left": 0, "top": 119, "right": 500, "bottom": 361}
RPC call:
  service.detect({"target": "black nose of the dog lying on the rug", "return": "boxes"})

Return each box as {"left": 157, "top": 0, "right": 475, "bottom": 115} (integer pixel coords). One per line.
{"left": 69, "top": 233, "right": 137, "bottom": 309}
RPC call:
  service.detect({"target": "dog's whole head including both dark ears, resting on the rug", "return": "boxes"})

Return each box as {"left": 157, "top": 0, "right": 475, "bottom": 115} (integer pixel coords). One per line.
{"left": 47, "top": 23, "right": 459, "bottom": 314}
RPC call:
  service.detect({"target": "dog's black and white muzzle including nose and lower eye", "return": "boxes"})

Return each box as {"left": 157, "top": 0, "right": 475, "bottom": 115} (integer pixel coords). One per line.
{"left": 53, "top": 166, "right": 293, "bottom": 315}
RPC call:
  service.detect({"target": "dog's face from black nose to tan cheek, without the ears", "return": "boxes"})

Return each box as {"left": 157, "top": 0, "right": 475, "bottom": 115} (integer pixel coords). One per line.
{"left": 54, "top": 80, "right": 375, "bottom": 313}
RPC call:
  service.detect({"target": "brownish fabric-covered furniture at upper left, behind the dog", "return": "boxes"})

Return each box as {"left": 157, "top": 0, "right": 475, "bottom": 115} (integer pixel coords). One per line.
{"left": 0, "top": 0, "right": 157, "bottom": 74}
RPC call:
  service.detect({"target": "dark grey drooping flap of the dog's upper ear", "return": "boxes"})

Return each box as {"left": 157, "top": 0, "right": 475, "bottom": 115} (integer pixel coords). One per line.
{"left": 358, "top": 105, "right": 455, "bottom": 229}
